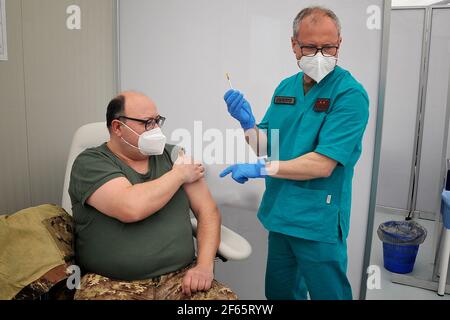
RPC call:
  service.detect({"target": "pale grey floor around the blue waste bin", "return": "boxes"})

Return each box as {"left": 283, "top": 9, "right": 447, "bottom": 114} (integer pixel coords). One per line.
{"left": 366, "top": 212, "right": 450, "bottom": 300}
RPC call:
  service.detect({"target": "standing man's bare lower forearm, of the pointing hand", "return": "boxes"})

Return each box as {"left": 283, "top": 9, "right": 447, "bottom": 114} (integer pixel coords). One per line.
{"left": 266, "top": 152, "right": 337, "bottom": 181}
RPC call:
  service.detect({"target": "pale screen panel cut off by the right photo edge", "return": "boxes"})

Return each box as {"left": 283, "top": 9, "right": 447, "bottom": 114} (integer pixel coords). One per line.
{"left": 416, "top": 8, "right": 450, "bottom": 213}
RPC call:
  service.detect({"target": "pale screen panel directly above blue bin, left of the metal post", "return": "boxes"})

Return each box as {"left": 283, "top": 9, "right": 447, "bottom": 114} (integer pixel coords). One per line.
{"left": 377, "top": 9, "right": 426, "bottom": 210}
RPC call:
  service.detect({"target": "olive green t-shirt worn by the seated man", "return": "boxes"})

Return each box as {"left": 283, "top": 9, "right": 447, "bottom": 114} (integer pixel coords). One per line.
{"left": 69, "top": 143, "right": 195, "bottom": 280}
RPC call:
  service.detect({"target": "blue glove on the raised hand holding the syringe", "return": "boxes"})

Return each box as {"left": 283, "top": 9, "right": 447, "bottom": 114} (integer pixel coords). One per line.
{"left": 224, "top": 90, "right": 256, "bottom": 130}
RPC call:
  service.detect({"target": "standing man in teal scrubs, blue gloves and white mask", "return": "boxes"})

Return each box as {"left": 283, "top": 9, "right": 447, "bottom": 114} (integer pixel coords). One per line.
{"left": 221, "top": 7, "right": 369, "bottom": 300}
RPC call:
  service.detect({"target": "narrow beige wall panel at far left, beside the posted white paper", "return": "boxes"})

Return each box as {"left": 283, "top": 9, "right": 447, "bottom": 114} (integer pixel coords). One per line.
{"left": 0, "top": 0, "right": 30, "bottom": 214}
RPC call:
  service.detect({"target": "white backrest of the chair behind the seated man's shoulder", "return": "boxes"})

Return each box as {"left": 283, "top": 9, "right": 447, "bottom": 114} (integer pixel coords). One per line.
{"left": 61, "top": 122, "right": 109, "bottom": 215}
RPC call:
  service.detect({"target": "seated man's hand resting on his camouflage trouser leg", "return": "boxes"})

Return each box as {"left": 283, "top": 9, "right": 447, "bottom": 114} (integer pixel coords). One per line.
{"left": 182, "top": 265, "right": 214, "bottom": 297}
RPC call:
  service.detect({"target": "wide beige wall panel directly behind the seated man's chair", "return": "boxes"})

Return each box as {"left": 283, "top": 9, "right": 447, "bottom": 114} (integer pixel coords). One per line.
{"left": 22, "top": 0, "right": 116, "bottom": 205}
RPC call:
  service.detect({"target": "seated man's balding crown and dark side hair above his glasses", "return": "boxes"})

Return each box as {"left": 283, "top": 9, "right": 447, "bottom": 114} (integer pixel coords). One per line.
{"left": 106, "top": 91, "right": 158, "bottom": 130}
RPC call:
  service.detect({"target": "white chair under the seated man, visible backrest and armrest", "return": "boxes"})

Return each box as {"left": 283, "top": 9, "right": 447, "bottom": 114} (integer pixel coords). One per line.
{"left": 62, "top": 122, "right": 252, "bottom": 261}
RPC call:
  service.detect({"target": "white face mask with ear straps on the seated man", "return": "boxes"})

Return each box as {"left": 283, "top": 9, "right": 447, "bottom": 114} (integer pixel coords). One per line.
{"left": 120, "top": 122, "right": 167, "bottom": 156}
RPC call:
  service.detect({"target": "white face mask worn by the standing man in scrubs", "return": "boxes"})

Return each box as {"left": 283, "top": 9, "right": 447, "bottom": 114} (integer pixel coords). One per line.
{"left": 297, "top": 52, "right": 337, "bottom": 83}
